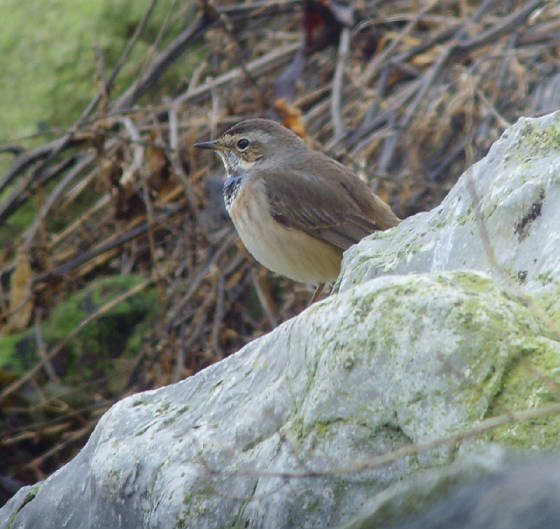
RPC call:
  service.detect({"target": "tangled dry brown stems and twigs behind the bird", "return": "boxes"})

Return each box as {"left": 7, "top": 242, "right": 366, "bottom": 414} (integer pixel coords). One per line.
{"left": 0, "top": 0, "right": 560, "bottom": 504}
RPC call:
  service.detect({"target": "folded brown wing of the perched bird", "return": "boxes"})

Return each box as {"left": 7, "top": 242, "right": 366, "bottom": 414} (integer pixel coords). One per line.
{"left": 262, "top": 160, "right": 399, "bottom": 250}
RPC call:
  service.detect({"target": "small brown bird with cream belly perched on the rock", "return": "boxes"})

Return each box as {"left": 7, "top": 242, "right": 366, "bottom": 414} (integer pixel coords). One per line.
{"left": 194, "top": 118, "right": 400, "bottom": 286}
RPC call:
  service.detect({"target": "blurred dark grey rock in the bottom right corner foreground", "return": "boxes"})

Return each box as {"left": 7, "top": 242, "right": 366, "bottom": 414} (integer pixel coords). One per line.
{"left": 340, "top": 446, "right": 560, "bottom": 529}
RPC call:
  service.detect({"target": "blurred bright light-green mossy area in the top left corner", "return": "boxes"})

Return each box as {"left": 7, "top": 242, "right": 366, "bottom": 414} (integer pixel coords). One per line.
{"left": 0, "top": 0, "right": 203, "bottom": 143}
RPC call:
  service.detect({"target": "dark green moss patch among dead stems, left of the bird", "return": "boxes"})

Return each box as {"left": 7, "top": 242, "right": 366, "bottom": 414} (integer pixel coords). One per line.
{"left": 0, "top": 276, "right": 157, "bottom": 389}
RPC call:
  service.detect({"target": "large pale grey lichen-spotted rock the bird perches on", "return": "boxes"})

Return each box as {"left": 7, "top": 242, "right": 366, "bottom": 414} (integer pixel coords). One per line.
{"left": 0, "top": 114, "right": 560, "bottom": 529}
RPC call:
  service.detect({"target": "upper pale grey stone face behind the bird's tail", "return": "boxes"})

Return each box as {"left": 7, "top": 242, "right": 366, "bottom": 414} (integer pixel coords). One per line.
{"left": 339, "top": 112, "right": 560, "bottom": 304}
